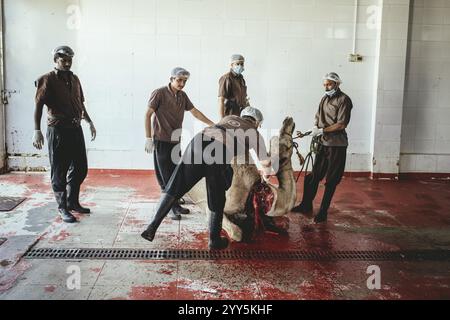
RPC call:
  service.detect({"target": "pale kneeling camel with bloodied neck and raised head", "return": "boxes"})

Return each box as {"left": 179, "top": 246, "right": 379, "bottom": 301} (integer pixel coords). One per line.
{"left": 189, "top": 117, "right": 296, "bottom": 242}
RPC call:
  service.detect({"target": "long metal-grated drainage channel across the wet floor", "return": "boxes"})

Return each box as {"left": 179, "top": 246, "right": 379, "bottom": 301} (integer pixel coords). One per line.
{"left": 25, "top": 248, "right": 450, "bottom": 261}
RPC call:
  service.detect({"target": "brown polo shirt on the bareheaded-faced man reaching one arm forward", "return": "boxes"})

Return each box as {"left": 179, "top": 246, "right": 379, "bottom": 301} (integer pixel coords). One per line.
{"left": 148, "top": 84, "right": 194, "bottom": 143}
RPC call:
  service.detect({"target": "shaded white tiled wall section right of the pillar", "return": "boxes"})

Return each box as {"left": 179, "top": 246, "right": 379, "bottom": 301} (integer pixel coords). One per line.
{"left": 400, "top": 0, "right": 450, "bottom": 173}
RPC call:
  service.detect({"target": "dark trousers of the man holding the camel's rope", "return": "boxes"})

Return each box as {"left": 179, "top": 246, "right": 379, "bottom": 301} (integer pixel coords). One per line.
{"left": 302, "top": 145, "right": 347, "bottom": 212}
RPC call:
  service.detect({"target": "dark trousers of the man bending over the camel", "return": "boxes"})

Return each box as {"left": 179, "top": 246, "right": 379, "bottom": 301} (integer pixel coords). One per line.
{"left": 165, "top": 133, "right": 233, "bottom": 213}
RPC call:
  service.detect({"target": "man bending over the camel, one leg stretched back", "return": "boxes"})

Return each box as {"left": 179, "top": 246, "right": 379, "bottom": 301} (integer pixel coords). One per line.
{"left": 141, "top": 107, "right": 271, "bottom": 249}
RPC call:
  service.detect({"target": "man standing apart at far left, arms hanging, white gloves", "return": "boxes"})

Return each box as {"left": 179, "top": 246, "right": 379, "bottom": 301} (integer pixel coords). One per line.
{"left": 33, "top": 46, "right": 97, "bottom": 223}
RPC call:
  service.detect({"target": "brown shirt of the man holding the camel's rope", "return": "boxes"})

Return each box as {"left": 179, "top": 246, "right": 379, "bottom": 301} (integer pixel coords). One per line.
{"left": 316, "top": 90, "right": 353, "bottom": 147}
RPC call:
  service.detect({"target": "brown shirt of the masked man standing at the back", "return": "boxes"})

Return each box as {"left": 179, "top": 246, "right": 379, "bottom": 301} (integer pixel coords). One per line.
{"left": 219, "top": 71, "right": 247, "bottom": 116}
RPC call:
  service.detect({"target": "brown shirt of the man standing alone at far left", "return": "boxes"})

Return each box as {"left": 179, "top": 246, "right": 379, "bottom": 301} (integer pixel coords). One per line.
{"left": 35, "top": 69, "right": 85, "bottom": 126}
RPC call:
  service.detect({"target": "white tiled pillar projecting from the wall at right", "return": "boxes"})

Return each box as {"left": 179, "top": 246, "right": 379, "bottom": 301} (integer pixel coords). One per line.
{"left": 371, "top": 0, "right": 409, "bottom": 174}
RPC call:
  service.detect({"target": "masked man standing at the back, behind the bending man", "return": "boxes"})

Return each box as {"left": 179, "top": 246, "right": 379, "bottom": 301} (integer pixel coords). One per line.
{"left": 219, "top": 54, "right": 249, "bottom": 118}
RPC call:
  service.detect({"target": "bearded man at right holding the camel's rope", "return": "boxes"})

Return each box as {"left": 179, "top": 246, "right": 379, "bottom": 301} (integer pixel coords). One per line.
{"left": 292, "top": 72, "right": 353, "bottom": 223}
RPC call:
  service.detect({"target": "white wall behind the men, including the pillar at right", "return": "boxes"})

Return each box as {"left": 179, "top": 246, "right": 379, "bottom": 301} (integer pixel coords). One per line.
{"left": 5, "top": 0, "right": 450, "bottom": 173}
